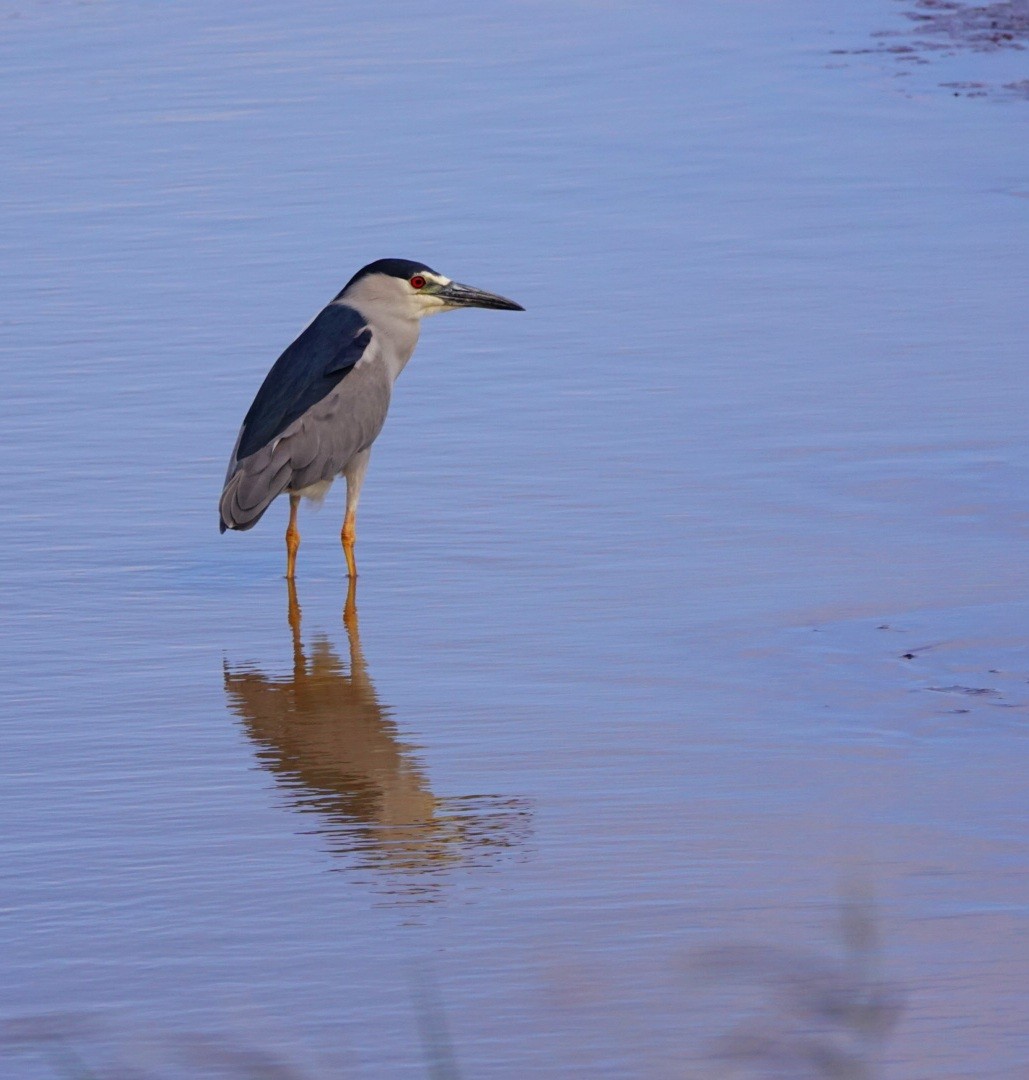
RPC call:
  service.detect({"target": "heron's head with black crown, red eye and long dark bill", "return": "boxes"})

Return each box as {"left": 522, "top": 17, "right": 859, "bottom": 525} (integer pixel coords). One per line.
{"left": 336, "top": 259, "right": 525, "bottom": 319}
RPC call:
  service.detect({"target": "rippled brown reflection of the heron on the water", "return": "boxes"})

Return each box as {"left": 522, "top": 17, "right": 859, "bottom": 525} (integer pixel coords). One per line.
{"left": 225, "top": 579, "right": 528, "bottom": 873}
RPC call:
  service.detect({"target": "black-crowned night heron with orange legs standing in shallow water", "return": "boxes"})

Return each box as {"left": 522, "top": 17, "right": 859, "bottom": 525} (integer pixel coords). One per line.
{"left": 219, "top": 259, "right": 525, "bottom": 579}
